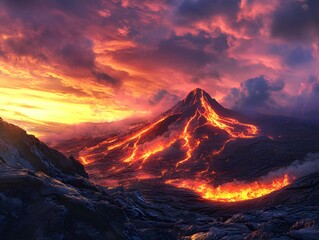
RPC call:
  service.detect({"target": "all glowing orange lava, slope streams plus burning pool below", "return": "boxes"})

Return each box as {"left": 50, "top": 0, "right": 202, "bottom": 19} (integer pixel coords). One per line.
{"left": 80, "top": 91, "right": 293, "bottom": 202}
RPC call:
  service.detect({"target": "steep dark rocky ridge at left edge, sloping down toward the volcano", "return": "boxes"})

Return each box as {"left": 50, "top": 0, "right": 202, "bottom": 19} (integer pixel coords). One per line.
{"left": 0, "top": 118, "right": 88, "bottom": 177}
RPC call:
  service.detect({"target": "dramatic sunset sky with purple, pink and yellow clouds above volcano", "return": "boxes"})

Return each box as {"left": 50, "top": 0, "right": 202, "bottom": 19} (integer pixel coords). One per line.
{"left": 0, "top": 0, "right": 319, "bottom": 136}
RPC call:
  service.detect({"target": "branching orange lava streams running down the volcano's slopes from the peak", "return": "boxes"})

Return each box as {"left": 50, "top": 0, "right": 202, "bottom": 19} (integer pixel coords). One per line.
{"left": 80, "top": 88, "right": 258, "bottom": 169}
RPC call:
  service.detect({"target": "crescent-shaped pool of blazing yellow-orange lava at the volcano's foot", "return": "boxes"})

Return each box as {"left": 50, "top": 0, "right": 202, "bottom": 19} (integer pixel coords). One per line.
{"left": 166, "top": 174, "right": 294, "bottom": 202}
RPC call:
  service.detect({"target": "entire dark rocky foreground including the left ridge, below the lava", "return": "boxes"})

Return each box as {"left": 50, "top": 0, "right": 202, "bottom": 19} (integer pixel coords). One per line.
{"left": 0, "top": 120, "right": 319, "bottom": 240}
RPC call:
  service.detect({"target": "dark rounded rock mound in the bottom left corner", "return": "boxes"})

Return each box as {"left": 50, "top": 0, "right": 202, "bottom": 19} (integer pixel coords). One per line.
{"left": 0, "top": 165, "right": 133, "bottom": 239}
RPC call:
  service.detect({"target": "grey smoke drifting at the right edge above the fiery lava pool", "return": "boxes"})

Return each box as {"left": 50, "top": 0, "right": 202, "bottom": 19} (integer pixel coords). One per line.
{"left": 265, "top": 153, "right": 319, "bottom": 181}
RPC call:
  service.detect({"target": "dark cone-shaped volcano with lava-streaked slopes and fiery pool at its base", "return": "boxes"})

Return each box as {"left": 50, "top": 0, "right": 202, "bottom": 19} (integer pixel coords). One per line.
{"left": 57, "top": 89, "right": 318, "bottom": 202}
